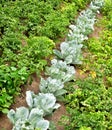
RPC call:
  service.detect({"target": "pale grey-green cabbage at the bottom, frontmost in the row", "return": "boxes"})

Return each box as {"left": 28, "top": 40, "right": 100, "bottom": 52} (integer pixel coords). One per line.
{"left": 7, "top": 107, "right": 49, "bottom": 130}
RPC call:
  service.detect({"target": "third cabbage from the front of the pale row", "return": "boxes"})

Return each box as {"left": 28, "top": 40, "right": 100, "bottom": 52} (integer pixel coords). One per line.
{"left": 39, "top": 77, "right": 67, "bottom": 98}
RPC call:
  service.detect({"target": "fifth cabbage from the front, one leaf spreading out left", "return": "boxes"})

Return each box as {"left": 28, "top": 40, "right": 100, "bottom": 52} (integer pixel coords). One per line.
{"left": 54, "top": 40, "right": 83, "bottom": 64}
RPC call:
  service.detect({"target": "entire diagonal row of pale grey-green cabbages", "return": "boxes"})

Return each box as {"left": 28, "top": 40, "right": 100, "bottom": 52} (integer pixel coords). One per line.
{"left": 8, "top": 0, "right": 103, "bottom": 130}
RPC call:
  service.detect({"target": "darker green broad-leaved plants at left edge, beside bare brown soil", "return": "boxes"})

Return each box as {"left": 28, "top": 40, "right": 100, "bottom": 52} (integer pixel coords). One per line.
{"left": 0, "top": 65, "right": 29, "bottom": 113}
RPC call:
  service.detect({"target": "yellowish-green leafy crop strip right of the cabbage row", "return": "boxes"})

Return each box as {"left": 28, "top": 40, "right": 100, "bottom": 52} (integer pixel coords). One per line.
{"left": 62, "top": 0, "right": 112, "bottom": 130}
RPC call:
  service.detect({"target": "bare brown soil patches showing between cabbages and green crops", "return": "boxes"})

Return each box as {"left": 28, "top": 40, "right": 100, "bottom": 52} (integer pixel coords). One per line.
{"left": 0, "top": 14, "right": 102, "bottom": 130}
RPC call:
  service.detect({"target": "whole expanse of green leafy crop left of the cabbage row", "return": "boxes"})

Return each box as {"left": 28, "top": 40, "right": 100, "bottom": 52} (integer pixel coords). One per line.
{"left": 0, "top": 0, "right": 89, "bottom": 113}
